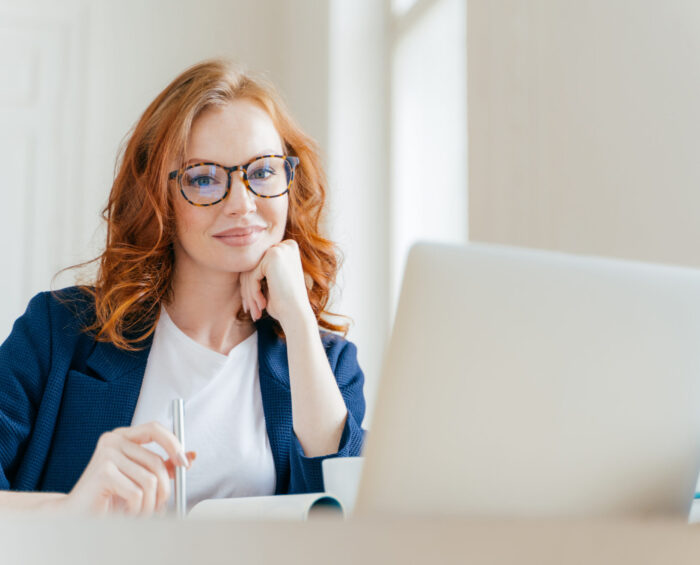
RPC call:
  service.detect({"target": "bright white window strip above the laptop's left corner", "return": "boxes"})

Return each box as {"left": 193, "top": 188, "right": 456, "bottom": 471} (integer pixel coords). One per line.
{"left": 389, "top": 0, "right": 468, "bottom": 312}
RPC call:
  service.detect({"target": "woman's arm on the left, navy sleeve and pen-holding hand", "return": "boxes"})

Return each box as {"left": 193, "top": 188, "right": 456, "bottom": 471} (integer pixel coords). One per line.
{"left": 0, "top": 293, "right": 194, "bottom": 516}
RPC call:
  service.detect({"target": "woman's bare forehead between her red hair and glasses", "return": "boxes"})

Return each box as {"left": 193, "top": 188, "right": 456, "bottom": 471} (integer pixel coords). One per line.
{"left": 186, "top": 99, "right": 283, "bottom": 165}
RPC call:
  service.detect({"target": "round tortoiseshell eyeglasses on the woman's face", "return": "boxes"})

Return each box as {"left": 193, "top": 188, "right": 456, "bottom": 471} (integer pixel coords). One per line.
{"left": 168, "top": 155, "right": 299, "bottom": 206}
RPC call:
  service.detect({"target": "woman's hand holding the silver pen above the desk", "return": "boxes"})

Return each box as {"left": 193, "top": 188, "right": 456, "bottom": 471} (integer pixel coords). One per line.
{"left": 62, "top": 422, "right": 195, "bottom": 516}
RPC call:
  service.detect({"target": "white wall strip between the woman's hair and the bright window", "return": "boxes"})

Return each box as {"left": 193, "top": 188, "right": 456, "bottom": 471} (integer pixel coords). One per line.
{"left": 328, "top": 0, "right": 390, "bottom": 427}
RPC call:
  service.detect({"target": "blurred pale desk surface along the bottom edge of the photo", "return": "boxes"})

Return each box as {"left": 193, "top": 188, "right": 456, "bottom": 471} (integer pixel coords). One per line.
{"left": 0, "top": 514, "right": 700, "bottom": 565}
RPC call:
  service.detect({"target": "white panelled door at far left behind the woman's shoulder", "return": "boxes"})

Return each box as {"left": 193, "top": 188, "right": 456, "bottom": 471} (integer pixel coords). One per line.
{"left": 0, "top": 1, "right": 87, "bottom": 338}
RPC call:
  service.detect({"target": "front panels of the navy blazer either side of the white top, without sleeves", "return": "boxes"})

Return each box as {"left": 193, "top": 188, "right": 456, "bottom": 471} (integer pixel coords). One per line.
{"left": 41, "top": 319, "right": 292, "bottom": 494}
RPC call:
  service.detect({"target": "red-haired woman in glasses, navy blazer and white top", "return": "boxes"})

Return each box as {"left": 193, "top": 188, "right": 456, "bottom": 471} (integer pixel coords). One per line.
{"left": 0, "top": 61, "right": 365, "bottom": 515}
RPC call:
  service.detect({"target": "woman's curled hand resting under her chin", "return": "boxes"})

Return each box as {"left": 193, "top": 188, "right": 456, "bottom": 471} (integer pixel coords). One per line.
{"left": 240, "top": 239, "right": 314, "bottom": 328}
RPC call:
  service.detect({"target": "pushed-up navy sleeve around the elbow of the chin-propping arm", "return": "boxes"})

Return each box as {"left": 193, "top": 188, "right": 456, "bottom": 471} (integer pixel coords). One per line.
{"left": 289, "top": 340, "right": 365, "bottom": 494}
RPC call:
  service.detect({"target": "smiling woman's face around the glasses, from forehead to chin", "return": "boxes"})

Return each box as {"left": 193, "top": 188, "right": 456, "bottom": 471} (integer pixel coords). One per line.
{"left": 171, "top": 99, "right": 289, "bottom": 273}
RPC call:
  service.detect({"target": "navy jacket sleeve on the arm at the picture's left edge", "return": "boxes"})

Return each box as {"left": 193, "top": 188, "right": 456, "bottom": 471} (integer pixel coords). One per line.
{"left": 0, "top": 293, "right": 51, "bottom": 490}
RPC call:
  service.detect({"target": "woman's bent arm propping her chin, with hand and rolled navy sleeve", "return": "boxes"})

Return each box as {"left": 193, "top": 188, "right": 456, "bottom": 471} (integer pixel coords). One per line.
{"left": 240, "top": 239, "right": 365, "bottom": 493}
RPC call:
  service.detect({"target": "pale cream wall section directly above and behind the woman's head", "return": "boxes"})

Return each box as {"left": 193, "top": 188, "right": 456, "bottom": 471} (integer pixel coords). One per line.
{"left": 84, "top": 0, "right": 328, "bottom": 274}
